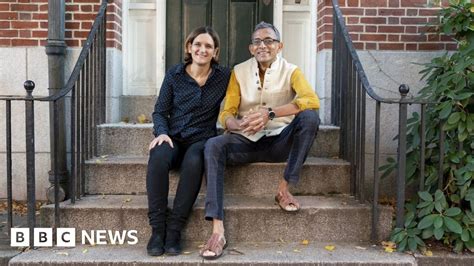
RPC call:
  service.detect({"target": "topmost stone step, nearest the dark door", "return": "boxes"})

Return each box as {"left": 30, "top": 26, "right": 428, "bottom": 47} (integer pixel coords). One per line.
{"left": 98, "top": 123, "right": 339, "bottom": 157}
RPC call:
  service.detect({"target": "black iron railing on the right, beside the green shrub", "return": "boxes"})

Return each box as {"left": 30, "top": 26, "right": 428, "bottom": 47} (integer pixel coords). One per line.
{"left": 331, "top": 0, "right": 444, "bottom": 240}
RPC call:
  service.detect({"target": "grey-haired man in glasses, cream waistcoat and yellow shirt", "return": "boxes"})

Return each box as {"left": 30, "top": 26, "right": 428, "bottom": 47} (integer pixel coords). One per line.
{"left": 200, "top": 22, "right": 319, "bottom": 259}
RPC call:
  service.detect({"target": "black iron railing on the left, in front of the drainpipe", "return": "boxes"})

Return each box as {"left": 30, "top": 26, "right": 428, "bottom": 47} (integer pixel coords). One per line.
{"left": 0, "top": 1, "right": 107, "bottom": 245}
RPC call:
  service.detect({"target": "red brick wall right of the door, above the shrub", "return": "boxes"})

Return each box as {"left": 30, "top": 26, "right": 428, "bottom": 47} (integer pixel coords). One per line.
{"left": 317, "top": 0, "right": 456, "bottom": 51}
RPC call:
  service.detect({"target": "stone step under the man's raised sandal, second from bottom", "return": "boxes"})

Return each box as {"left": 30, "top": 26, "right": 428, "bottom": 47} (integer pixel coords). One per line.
{"left": 41, "top": 195, "right": 392, "bottom": 244}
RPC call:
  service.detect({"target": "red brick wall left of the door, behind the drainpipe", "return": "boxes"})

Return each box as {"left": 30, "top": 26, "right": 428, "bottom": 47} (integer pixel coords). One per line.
{"left": 0, "top": 0, "right": 122, "bottom": 49}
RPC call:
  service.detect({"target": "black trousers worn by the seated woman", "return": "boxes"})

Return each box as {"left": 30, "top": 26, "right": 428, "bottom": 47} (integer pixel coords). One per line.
{"left": 146, "top": 140, "right": 206, "bottom": 231}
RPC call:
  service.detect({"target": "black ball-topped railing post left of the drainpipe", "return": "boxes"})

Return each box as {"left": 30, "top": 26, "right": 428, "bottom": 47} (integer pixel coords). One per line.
{"left": 23, "top": 80, "right": 36, "bottom": 247}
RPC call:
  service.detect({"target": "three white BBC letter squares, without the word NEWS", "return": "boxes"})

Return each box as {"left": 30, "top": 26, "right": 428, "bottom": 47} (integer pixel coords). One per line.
{"left": 10, "top": 228, "right": 76, "bottom": 247}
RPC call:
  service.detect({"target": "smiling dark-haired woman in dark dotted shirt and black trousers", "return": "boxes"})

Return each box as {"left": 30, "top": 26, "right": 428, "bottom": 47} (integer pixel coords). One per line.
{"left": 146, "top": 27, "right": 230, "bottom": 256}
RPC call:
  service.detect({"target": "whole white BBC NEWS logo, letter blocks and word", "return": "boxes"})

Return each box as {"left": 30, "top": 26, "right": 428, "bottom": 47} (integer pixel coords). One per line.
{"left": 10, "top": 228, "right": 138, "bottom": 247}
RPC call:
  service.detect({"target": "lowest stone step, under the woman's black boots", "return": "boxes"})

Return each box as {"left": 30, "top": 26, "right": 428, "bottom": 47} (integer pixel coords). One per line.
{"left": 6, "top": 242, "right": 414, "bottom": 266}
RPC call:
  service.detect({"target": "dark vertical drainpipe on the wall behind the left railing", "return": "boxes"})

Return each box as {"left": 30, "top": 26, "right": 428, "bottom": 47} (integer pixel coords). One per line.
{"left": 46, "top": 0, "right": 68, "bottom": 202}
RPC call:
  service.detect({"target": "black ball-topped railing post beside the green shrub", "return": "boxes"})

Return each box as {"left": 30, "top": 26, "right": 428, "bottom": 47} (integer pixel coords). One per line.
{"left": 396, "top": 84, "right": 410, "bottom": 228}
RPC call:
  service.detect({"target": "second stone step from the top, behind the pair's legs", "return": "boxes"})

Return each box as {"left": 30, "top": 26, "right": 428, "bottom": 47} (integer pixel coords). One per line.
{"left": 86, "top": 156, "right": 350, "bottom": 195}
